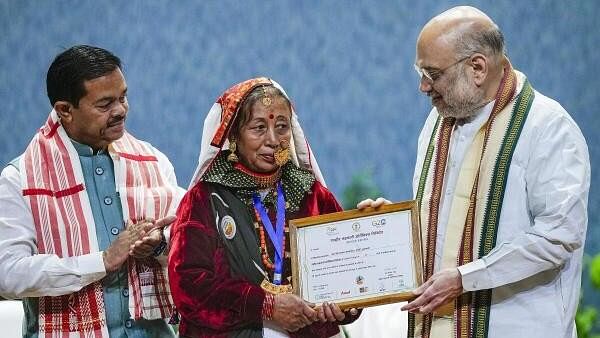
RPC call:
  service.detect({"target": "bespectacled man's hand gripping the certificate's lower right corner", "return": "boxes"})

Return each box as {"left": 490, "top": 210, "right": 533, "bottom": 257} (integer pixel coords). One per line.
{"left": 401, "top": 268, "right": 463, "bottom": 314}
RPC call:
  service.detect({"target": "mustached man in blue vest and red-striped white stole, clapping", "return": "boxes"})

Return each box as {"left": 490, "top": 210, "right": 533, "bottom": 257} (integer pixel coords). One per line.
{"left": 0, "top": 46, "right": 183, "bottom": 337}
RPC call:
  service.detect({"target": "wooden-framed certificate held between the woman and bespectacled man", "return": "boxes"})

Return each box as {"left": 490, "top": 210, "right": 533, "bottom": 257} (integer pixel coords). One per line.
{"left": 290, "top": 200, "right": 423, "bottom": 309}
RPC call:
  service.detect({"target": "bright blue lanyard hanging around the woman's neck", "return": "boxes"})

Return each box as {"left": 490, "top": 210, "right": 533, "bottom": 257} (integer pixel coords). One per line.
{"left": 252, "top": 181, "right": 285, "bottom": 285}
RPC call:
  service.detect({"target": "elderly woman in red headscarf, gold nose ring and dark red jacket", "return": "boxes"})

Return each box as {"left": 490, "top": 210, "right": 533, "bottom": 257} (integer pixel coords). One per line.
{"left": 169, "top": 78, "right": 358, "bottom": 337}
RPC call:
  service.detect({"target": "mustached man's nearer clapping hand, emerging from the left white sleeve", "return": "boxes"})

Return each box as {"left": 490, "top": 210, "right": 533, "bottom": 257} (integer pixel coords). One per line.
{"left": 102, "top": 222, "right": 154, "bottom": 272}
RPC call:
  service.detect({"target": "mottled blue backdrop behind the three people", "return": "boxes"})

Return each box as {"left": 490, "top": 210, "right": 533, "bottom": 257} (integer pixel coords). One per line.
{"left": 0, "top": 0, "right": 600, "bottom": 304}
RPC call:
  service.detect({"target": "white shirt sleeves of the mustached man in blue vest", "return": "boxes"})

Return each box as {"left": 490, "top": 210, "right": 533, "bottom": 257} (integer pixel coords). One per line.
{"left": 0, "top": 144, "right": 185, "bottom": 298}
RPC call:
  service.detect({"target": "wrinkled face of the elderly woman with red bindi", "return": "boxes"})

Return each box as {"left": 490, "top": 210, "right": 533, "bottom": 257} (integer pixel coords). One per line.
{"left": 237, "top": 96, "right": 292, "bottom": 173}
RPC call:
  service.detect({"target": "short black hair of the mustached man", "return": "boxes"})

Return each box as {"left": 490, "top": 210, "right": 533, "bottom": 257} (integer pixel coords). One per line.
{"left": 46, "top": 45, "right": 121, "bottom": 107}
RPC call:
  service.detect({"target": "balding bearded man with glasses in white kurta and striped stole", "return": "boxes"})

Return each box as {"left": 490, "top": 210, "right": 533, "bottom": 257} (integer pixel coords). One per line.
{"left": 359, "top": 6, "right": 590, "bottom": 338}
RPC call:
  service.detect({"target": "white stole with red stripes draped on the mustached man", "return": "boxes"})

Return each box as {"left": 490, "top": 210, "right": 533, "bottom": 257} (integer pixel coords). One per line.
{"left": 20, "top": 110, "right": 177, "bottom": 337}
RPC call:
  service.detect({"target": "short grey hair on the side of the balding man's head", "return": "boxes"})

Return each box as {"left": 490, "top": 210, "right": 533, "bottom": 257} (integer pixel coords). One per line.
{"left": 454, "top": 24, "right": 506, "bottom": 59}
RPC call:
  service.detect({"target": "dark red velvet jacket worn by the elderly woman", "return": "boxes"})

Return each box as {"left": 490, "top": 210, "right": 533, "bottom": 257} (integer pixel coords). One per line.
{"left": 169, "top": 181, "right": 357, "bottom": 338}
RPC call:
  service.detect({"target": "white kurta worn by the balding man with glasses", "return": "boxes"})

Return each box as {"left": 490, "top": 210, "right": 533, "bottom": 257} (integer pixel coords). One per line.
{"left": 413, "top": 82, "right": 590, "bottom": 338}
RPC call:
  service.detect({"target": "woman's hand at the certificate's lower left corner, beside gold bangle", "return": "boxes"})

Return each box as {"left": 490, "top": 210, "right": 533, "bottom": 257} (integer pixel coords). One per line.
{"left": 272, "top": 294, "right": 318, "bottom": 332}
